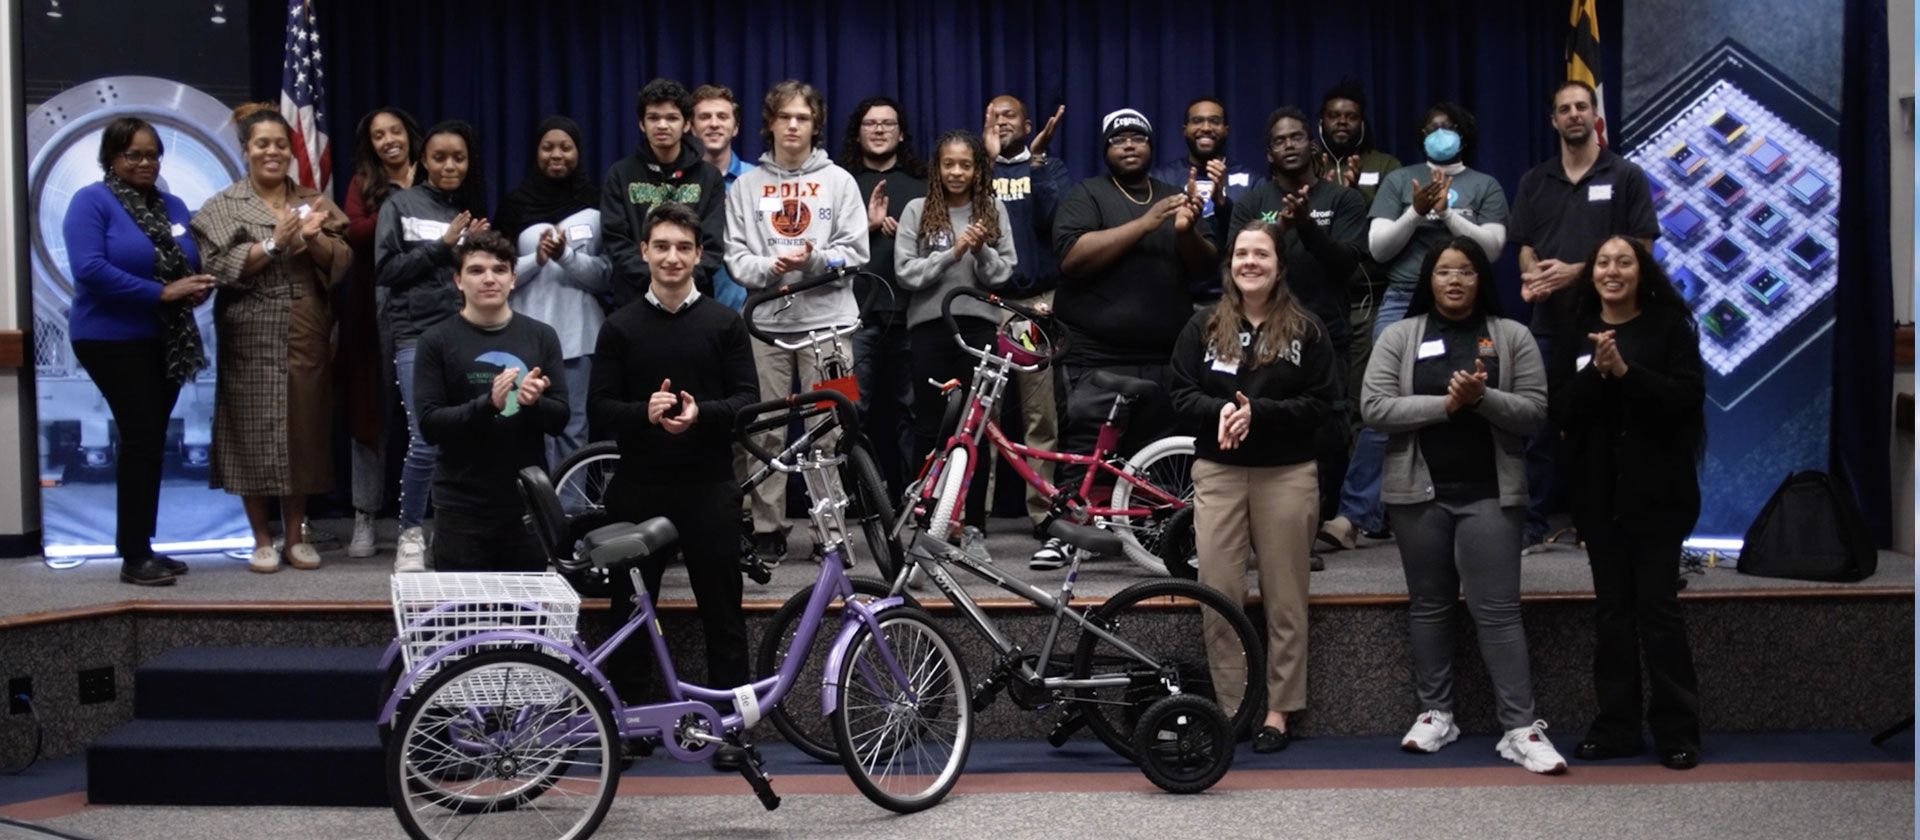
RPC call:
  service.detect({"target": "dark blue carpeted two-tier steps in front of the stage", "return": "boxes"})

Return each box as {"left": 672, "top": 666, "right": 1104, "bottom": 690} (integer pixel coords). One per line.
{"left": 86, "top": 648, "right": 386, "bottom": 805}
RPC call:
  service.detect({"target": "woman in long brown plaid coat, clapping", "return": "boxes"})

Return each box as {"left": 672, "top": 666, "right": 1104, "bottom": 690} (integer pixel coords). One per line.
{"left": 192, "top": 104, "right": 353, "bottom": 572}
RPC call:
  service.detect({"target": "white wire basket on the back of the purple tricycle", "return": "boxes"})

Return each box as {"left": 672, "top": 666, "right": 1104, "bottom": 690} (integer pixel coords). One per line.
{"left": 392, "top": 572, "right": 580, "bottom": 687}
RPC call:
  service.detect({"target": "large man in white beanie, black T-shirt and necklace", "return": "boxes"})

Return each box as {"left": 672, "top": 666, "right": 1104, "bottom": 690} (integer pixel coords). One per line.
{"left": 1054, "top": 107, "right": 1215, "bottom": 552}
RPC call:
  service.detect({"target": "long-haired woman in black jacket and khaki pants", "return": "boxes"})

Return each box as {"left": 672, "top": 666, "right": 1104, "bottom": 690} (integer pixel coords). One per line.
{"left": 1171, "top": 221, "right": 1340, "bottom": 752}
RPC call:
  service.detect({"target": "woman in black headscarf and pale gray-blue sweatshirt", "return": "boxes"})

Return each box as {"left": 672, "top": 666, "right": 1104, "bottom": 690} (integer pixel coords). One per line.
{"left": 493, "top": 117, "right": 612, "bottom": 466}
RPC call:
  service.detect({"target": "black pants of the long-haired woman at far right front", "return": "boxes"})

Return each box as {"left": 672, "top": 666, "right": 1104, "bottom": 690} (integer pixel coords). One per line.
{"left": 1580, "top": 527, "right": 1699, "bottom": 752}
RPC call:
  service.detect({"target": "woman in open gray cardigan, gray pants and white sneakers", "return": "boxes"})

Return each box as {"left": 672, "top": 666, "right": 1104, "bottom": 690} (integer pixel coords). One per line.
{"left": 1361, "top": 238, "right": 1567, "bottom": 773}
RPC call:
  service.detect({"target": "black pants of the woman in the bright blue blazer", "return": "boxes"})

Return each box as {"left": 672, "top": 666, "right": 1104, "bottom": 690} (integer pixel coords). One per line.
{"left": 73, "top": 338, "right": 180, "bottom": 562}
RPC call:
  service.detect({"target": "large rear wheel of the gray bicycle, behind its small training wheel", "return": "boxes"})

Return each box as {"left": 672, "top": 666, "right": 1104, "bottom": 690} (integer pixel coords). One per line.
{"left": 1073, "top": 577, "right": 1267, "bottom": 761}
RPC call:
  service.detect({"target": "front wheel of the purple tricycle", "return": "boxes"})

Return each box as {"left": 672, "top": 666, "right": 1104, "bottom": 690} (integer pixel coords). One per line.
{"left": 831, "top": 608, "right": 973, "bottom": 813}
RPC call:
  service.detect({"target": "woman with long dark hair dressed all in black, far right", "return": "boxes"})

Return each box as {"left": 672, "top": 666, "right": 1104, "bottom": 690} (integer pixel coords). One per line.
{"left": 1551, "top": 236, "right": 1707, "bottom": 769}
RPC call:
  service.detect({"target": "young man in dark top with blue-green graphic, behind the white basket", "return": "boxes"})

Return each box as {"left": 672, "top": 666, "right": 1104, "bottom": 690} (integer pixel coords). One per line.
{"left": 413, "top": 230, "right": 570, "bottom": 572}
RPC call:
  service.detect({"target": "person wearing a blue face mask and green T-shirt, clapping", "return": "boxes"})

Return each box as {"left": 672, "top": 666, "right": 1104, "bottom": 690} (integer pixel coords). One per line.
{"left": 1323, "top": 102, "right": 1507, "bottom": 548}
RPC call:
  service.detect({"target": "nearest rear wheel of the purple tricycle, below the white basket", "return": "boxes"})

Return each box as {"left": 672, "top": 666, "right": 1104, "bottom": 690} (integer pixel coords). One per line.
{"left": 386, "top": 650, "right": 620, "bottom": 840}
